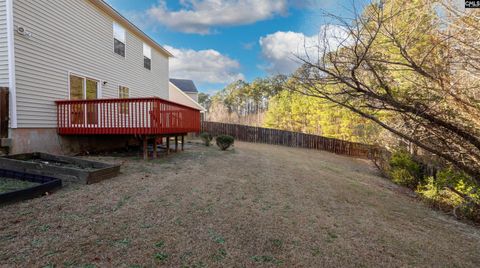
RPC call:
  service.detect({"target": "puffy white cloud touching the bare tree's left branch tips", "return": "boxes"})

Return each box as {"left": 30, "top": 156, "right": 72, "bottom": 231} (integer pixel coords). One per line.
{"left": 259, "top": 26, "right": 348, "bottom": 74}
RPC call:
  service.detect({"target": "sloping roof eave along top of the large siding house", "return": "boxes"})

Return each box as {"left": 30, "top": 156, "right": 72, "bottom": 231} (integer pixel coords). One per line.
{"left": 89, "top": 0, "right": 173, "bottom": 57}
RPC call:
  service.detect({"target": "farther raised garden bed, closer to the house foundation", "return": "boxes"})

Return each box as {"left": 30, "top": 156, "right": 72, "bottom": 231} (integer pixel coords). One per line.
{"left": 0, "top": 153, "right": 120, "bottom": 184}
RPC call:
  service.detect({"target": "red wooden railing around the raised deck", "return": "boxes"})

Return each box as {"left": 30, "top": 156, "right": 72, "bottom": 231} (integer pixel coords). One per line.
{"left": 55, "top": 97, "right": 200, "bottom": 135}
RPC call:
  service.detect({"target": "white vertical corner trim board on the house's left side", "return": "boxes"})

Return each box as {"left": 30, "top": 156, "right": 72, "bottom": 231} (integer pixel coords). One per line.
{"left": 6, "top": 0, "right": 18, "bottom": 129}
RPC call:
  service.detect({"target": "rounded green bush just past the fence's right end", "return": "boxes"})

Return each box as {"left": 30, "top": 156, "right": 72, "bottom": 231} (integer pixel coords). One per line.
{"left": 389, "top": 151, "right": 423, "bottom": 189}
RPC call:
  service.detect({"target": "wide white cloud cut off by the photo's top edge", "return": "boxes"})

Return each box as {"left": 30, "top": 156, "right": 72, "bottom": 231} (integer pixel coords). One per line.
{"left": 147, "top": 0, "right": 287, "bottom": 34}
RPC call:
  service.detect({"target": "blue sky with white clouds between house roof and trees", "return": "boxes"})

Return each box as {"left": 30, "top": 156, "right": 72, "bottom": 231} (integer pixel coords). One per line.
{"left": 107, "top": 0, "right": 366, "bottom": 93}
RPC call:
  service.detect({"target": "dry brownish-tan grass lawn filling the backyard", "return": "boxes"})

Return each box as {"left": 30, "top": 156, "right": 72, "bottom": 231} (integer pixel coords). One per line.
{"left": 0, "top": 142, "right": 480, "bottom": 267}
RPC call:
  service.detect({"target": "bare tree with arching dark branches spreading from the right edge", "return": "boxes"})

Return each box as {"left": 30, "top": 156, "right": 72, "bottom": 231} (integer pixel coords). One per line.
{"left": 291, "top": 0, "right": 480, "bottom": 183}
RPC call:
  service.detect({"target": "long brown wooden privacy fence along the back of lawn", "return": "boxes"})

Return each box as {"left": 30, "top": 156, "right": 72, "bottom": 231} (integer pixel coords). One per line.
{"left": 202, "top": 121, "right": 378, "bottom": 159}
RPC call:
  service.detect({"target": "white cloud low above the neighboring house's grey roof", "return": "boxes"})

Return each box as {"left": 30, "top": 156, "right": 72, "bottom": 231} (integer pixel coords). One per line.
{"left": 165, "top": 46, "right": 244, "bottom": 83}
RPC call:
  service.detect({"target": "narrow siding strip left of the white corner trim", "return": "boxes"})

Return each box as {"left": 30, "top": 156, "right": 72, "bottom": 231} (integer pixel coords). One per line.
{"left": 0, "top": 0, "right": 8, "bottom": 87}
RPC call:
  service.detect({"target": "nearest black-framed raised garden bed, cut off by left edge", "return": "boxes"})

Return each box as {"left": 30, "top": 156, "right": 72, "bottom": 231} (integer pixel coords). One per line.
{"left": 0, "top": 169, "right": 62, "bottom": 204}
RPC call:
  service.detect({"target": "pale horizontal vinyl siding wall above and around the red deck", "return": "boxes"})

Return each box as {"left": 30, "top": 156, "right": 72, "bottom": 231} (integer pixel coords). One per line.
{"left": 12, "top": 0, "right": 168, "bottom": 128}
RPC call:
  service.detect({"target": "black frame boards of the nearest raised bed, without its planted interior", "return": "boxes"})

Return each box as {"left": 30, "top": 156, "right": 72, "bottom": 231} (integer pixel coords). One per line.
{"left": 0, "top": 169, "right": 62, "bottom": 204}
